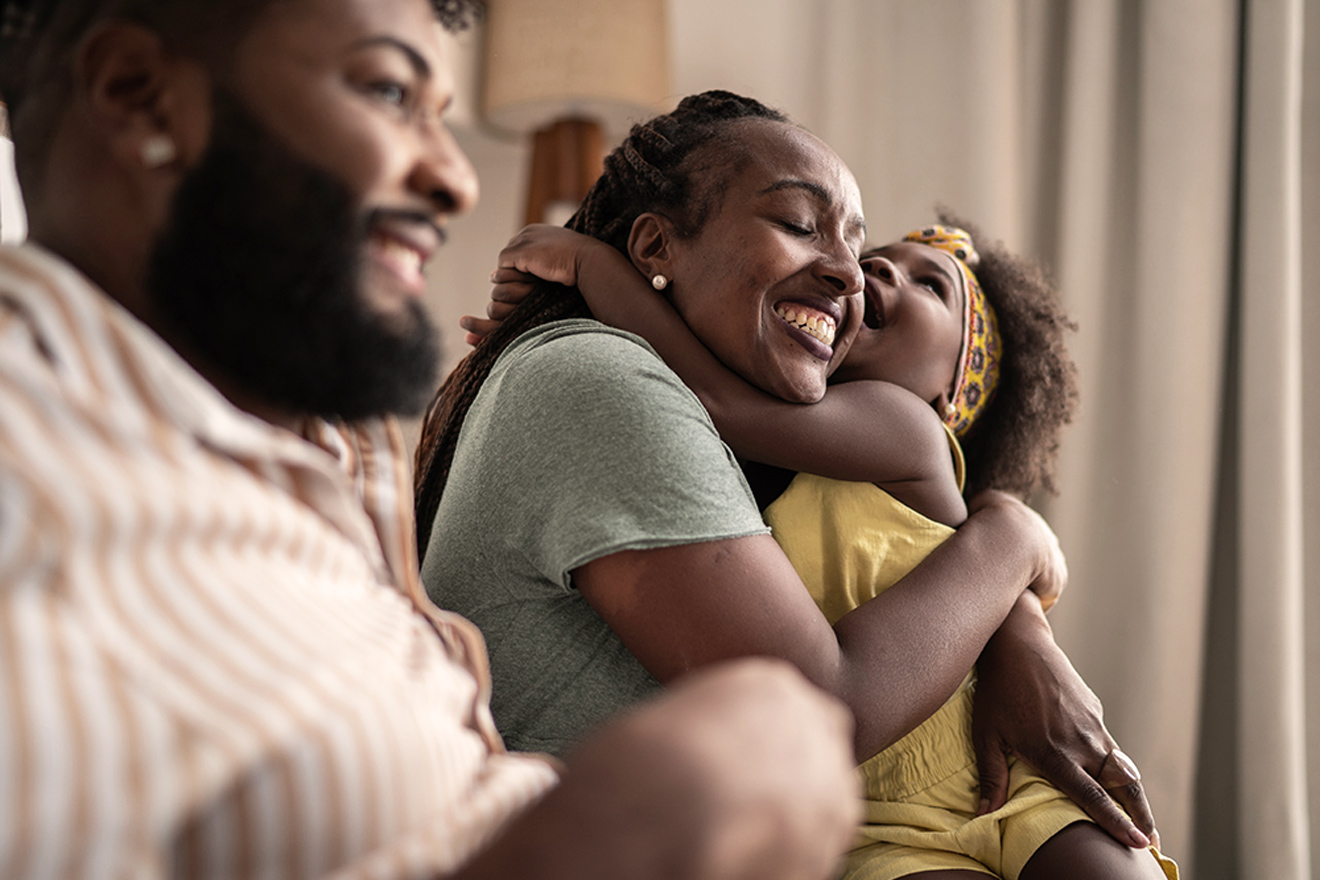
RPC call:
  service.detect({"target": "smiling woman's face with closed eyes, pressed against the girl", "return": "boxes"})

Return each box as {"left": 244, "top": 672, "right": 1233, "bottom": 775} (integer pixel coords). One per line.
{"left": 669, "top": 120, "right": 866, "bottom": 402}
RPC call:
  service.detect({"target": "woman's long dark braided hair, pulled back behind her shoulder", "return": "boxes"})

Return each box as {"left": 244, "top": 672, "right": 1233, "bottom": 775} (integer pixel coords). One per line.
{"left": 414, "top": 91, "right": 788, "bottom": 555}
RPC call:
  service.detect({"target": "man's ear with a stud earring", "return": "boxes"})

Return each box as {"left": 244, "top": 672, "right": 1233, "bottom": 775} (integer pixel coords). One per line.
{"left": 74, "top": 21, "right": 211, "bottom": 173}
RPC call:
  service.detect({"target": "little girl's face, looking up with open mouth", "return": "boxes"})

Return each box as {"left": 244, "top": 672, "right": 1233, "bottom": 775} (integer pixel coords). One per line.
{"left": 834, "top": 241, "right": 966, "bottom": 402}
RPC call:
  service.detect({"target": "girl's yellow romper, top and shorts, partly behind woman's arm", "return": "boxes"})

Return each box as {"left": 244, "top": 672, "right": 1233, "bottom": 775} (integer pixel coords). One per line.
{"left": 766, "top": 434, "right": 1177, "bottom": 880}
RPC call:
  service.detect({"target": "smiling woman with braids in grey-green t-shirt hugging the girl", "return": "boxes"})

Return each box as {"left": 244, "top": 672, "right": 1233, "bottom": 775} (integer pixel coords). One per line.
{"left": 417, "top": 92, "right": 1154, "bottom": 876}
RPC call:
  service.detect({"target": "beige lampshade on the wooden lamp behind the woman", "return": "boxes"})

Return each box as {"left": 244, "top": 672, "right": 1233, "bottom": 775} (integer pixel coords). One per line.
{"left": 483, "top": 0, "right": 671, "bottom": 135}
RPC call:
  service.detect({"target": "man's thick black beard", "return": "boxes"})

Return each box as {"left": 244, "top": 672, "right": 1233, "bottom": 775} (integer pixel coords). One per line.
{"left": 148, "top": 91, "right": 440, "bottom": 421}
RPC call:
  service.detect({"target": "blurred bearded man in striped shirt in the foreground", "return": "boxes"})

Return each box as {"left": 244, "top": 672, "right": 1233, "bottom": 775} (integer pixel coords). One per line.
{"left": 0, "top": 0, "right": 857, "bottom": 877}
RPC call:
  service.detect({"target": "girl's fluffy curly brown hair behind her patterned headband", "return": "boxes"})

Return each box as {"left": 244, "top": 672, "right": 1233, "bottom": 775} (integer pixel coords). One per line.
{"left": 939, "top": 210, "right": 1077, "bottom": 499}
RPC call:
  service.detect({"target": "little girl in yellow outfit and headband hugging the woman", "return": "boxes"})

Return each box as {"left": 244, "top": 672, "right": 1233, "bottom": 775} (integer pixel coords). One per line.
{"left": 465, "top": 218, "right": 1177, "bottom": 880}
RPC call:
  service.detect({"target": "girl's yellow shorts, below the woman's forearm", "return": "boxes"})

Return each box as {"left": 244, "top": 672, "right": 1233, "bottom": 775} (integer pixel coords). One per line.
{"left": 843, "top": 676, "right": 1177, "bottom": 880}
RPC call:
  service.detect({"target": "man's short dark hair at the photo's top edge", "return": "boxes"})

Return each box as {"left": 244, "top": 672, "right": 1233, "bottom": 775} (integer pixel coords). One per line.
{"left": 0, "top": 0, "right": 486, "bottom": 186}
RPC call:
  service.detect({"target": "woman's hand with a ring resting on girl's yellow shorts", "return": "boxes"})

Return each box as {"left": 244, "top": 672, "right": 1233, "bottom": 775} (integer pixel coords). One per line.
{"left": 972, "top": 592, "right": 1159, "bottom": 847}
